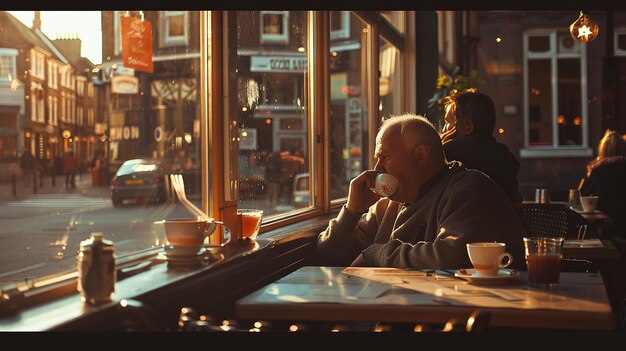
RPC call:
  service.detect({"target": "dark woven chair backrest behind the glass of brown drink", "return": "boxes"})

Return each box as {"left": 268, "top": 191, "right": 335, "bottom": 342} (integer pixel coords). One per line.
{"left": 519, "top": 203, "right": 588, "bottom": 239}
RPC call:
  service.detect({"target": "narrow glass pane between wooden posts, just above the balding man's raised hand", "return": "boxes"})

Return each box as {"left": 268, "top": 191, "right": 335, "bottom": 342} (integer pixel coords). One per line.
{"left": 328, "top": 14, "right": 369, "bottom": 200}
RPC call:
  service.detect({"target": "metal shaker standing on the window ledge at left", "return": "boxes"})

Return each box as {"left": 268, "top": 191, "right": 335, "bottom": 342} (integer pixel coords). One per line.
{"left": 77, "top": 232, "right": 116, "bottom": 305}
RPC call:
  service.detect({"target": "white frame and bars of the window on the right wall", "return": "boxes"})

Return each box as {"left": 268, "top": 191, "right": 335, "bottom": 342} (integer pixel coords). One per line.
{"left": 520, "top": 29, "right": 593, "bottom": 158}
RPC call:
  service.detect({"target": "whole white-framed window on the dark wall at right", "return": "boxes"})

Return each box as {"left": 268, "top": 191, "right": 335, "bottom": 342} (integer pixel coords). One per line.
{"left": 521, "top": 31, "right": 590, "bottom": 156}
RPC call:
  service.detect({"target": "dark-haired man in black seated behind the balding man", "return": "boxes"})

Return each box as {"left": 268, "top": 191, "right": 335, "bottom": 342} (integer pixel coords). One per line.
{"left": 441, "top": 90, "right": 522, "bottom": 204}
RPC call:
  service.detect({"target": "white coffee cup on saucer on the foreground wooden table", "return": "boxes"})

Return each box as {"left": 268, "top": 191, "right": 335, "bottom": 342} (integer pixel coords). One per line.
{"left": 466, "top": 242, "right": 513, "bottom": 277}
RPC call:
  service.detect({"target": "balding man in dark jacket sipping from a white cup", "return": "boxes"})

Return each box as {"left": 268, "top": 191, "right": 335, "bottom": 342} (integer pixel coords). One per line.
{"left": 314, "top": 114, "right": 526, "bottom": 269}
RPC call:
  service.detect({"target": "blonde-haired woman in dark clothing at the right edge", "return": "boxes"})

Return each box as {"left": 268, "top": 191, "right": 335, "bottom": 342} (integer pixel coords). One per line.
{"left": 579, "top": 129, "right": 626, "bottom": 238}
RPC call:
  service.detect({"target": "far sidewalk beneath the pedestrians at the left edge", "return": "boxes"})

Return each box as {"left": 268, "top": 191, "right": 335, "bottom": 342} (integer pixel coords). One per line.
{"left": 0, "top": 172, "right": 111, "bottom": 202}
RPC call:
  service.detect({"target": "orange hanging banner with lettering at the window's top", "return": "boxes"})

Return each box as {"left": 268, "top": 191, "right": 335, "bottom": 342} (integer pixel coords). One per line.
{"left": 120, "top": 15, "right": 154, "bottom": 73}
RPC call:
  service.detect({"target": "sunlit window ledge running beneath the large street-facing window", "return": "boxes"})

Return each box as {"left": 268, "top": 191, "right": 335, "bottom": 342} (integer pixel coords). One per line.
{"left": 0, "top": 216, "right": 328, "bottom": 331}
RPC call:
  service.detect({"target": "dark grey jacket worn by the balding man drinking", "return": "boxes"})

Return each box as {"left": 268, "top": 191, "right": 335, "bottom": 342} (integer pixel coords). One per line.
{"left": 315, "top": 162, "right": 526, "bottom": 270}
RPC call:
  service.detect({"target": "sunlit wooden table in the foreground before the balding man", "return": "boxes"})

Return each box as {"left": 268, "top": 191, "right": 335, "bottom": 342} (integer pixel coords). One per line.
{"left": 236, "top": 266, "right": 616, "bottom": 330}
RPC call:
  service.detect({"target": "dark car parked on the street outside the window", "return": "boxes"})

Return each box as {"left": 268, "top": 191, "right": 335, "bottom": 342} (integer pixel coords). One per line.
{"left": 111, "top": 159, "right": 168, "bottom": 206}
